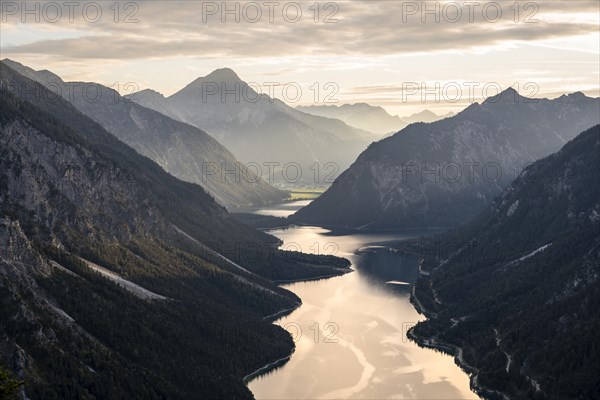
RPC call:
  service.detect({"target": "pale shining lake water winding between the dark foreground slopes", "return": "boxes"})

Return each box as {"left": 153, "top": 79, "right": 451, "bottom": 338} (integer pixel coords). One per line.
{"left": 248, "top": 226, "right": 477, "bottom": 399}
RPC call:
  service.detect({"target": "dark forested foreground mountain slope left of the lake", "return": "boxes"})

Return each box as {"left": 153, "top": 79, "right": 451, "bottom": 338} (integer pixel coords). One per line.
{"left": 0, "top": 63, "right": 349, "bottom": 399}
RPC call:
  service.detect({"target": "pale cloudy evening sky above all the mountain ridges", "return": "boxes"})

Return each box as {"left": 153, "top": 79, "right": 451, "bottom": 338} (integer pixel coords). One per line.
{"left": 0, "top": 0, "right": 600, "bottom": 116}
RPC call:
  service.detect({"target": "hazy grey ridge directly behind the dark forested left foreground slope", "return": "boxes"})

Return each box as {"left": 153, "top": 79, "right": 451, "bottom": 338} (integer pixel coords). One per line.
{"left": 1, "top": 59, "right": 287, "bottom": 209}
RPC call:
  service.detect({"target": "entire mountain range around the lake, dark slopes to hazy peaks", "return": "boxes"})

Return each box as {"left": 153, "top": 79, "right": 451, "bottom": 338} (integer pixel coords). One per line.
{"left": 0, "top": 60, "right": 600, "bottom": 400}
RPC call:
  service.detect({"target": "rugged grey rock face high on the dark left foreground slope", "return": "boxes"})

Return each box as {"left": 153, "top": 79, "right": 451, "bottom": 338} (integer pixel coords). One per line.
{"left": 0, "top": 120, "right": 159, "bottom": 241}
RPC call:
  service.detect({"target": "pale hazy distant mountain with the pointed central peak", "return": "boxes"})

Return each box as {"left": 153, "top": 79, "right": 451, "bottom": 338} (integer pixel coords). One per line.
{"left": 128, "top": 68, "right": 372, "bottom": 183}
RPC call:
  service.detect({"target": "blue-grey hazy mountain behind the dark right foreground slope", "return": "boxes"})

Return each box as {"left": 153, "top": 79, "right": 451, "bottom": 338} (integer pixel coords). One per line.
{"left": 291, "top": 89, "right": 600, "bottom": 228}
